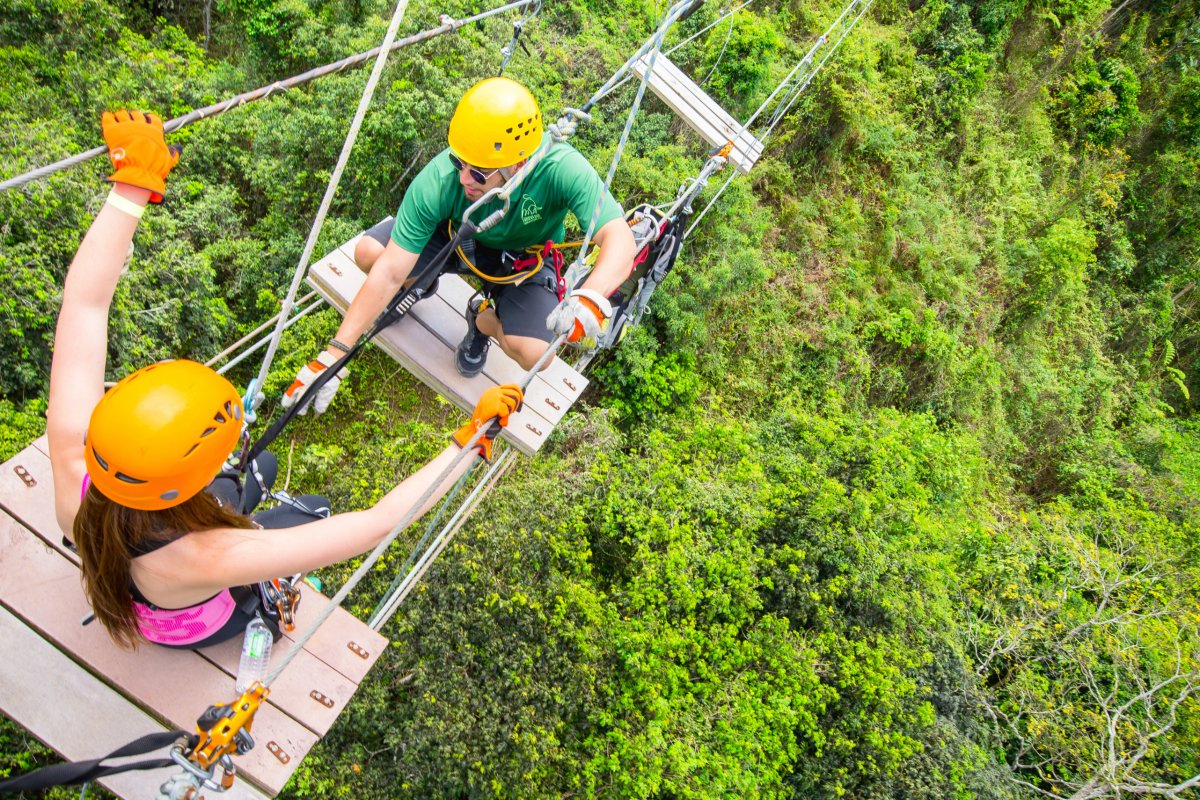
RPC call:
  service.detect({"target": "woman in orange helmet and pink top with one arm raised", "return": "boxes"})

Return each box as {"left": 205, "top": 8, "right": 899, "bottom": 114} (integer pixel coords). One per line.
{"left": 47, "top": 112, "right": 521, "bottom": 648}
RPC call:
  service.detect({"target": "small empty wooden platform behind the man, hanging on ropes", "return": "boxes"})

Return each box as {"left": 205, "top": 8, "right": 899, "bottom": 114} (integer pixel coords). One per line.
{"left": 634, "top": 53, "right": 762, "bottom": 174}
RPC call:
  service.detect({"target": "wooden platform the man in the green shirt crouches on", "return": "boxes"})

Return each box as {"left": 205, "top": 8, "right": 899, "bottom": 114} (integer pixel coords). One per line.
{"left": 308, "top": 235, "right": 588, "bottom": 455}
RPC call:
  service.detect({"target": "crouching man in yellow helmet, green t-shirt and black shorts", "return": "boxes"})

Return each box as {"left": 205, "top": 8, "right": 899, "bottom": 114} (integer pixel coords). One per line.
{"left": 283, "top": 78, "right": 636, "bottom": 414}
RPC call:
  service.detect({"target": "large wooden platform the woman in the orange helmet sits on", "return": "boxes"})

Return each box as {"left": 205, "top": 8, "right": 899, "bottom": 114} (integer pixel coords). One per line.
{"left": 0, "top": 439, "right": 388, "bottom": 800}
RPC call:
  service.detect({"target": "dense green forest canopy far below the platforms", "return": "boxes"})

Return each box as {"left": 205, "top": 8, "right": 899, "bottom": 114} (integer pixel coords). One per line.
{"left": 0, "top": 0, "right": 1200, "bottom": 800}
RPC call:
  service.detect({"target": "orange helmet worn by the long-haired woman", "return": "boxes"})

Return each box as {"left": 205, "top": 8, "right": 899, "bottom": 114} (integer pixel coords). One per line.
{"left": 84, "top": 360, "right": 242, "bottom": 511}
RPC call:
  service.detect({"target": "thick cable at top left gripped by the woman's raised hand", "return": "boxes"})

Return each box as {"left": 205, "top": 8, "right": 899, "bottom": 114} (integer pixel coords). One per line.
{"left": 0, "top": 0, "right": 541, "bottom": 192}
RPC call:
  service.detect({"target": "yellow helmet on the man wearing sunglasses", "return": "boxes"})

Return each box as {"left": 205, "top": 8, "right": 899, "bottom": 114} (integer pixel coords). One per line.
{"left": 448, "top": 78, "right": 542, "bottom": 169}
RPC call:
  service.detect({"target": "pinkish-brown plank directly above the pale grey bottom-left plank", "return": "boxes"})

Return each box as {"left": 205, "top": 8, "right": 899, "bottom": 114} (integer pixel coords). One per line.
{"left": 0, "top": 516, "right": 317, "bottom": 795}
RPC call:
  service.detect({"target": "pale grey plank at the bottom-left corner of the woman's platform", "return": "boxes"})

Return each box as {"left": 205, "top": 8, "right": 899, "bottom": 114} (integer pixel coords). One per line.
{"left": 0, "top": 608, "right": 268, "bottom": 800}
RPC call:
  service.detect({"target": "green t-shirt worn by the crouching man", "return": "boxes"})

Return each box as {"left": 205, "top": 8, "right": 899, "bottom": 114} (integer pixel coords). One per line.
{"left": 391, "top": 134, "right": 624, "bottom": 253}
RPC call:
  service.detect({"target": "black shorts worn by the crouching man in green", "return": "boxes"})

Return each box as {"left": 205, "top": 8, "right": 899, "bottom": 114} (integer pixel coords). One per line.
{"left": 365, "top": 217, "right": 558, "bottom": 343}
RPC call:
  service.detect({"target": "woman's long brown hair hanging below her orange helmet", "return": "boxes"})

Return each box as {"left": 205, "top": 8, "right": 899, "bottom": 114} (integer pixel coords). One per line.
{"left": 72, "top": 485, "right": 253, "bottom": 649}
